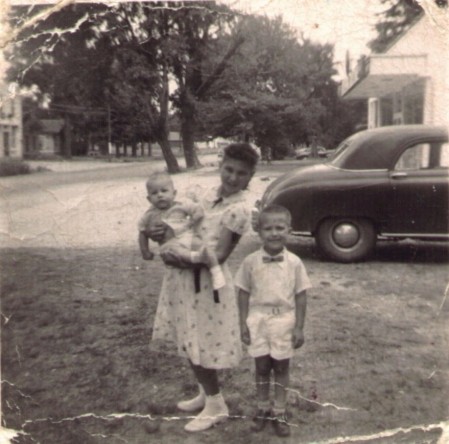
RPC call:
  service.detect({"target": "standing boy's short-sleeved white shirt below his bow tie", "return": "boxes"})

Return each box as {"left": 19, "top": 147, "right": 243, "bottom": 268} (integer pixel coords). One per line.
{"left": 235, "top": 247, "right": 312, "bottom": 309}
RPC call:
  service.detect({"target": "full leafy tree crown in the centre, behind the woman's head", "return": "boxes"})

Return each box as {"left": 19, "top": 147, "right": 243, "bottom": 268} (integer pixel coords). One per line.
{"left": 200, "top": 16, "right": 344, "bottom": 157}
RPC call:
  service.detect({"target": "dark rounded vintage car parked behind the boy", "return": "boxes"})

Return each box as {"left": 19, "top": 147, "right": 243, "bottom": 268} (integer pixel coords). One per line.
{"left": 260, "top": 125, "right": 449, "bottom": 262}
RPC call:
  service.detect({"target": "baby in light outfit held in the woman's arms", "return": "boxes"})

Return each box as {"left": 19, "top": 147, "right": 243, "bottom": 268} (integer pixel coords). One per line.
{"left": 138, "top": 172, "right": 225, "bottom": 290}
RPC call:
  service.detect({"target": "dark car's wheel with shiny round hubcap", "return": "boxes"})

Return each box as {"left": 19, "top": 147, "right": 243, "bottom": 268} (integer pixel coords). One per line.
{"left": 315, "top": 218, "right": 377, "bottom": 262}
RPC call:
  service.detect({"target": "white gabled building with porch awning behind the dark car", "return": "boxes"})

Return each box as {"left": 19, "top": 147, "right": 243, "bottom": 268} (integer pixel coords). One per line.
{"left": 340, "top": 14, "right": 449, "bottom": 128}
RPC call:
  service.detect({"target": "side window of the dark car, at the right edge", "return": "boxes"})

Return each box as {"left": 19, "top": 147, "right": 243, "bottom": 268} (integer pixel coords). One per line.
{"left": 394, "top": 142, "right": 449, "bottom": 170}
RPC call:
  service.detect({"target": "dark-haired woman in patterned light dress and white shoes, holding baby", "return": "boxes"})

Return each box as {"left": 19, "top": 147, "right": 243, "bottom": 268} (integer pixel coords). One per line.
{"left": 149, "top": 143, "right": 258, "bottom": 432}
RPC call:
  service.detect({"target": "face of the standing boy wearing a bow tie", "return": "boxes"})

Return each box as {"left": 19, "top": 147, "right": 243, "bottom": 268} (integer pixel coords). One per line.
{"left": 259, "top": 214, "right": 290, "bottom": 254}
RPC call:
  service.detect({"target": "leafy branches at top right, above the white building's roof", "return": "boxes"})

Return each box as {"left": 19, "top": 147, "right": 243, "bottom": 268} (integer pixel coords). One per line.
{"left": 369, "top": 0, "right": 447, "bottom": 52}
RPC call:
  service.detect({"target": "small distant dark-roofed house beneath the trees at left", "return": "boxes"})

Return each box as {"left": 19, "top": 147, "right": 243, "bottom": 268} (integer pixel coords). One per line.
{"left": 24, "top": 119, "right": 64, "bottom": 155}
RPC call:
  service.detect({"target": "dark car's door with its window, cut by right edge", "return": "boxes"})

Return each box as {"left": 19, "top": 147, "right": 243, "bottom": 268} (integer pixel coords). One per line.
{"left": 386, "top": 142, "right": 449, "bottom": 236}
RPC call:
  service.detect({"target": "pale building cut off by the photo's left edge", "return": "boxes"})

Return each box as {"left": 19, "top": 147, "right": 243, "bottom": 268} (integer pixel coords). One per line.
{"left": 0, "top": 86, "right": 23, "bottom": 158}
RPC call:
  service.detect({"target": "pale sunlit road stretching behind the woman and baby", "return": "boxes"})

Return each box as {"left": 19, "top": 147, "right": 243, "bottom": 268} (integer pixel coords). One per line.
{"left": 0, "top": 157, "right": 270, "bottom": 248}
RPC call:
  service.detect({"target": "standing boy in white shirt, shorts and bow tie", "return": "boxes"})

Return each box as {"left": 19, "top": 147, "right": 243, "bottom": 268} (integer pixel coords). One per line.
{"left": 235, "top": 205, "right": 311, "bottom": 436}
